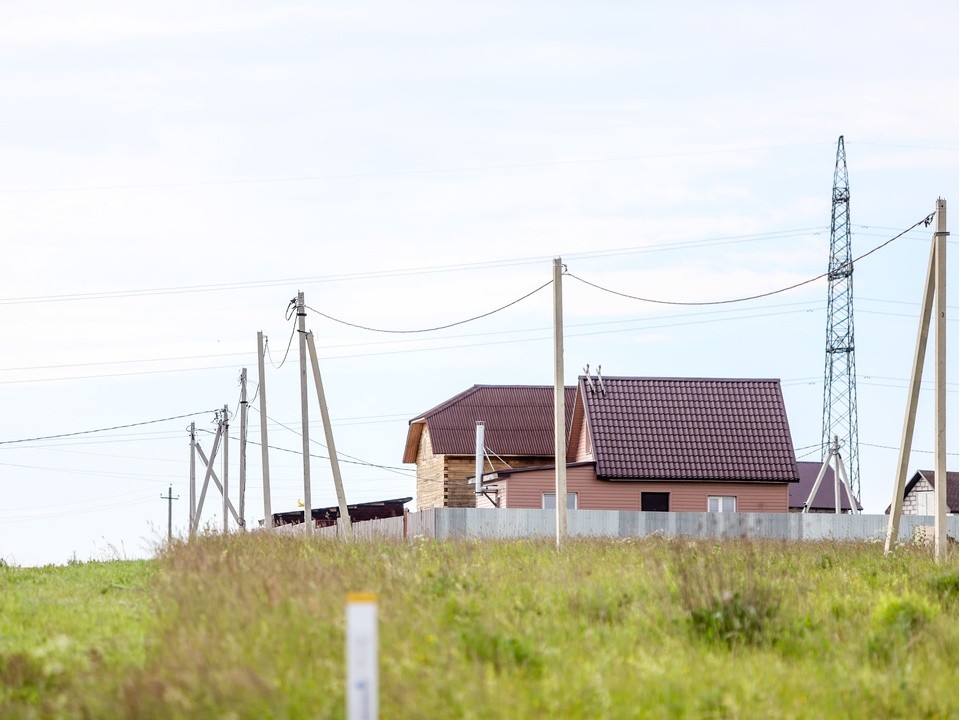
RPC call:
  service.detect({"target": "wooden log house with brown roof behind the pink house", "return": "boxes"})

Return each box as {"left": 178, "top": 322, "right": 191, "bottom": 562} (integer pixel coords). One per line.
{"left": 403, "top": 385, "right": 576, "bottom": 510}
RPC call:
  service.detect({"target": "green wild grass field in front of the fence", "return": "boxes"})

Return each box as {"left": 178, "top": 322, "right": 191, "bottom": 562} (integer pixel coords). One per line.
{"left": 0, "top": 533, "right": 958, "bottom": 719}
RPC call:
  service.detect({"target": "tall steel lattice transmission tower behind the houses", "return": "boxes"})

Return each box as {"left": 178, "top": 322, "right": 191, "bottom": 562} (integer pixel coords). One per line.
{"left": 821, "top": 135, "right": 860, "bottom": 499}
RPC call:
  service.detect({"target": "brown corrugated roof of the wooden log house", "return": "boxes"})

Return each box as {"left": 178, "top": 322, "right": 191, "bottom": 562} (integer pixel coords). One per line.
{"left": 403, "top": 385, "right": 576, "bottom": 463}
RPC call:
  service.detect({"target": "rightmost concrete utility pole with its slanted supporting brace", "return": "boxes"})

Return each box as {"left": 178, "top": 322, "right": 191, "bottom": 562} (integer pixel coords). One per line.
{"left": 884, "top": 198, "right": 949, "bottom": 562}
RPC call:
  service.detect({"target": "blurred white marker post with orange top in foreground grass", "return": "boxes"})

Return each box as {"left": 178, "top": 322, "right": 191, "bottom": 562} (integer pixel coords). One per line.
{"left": 347, "top": 593, "right": 380, "bottom": 720}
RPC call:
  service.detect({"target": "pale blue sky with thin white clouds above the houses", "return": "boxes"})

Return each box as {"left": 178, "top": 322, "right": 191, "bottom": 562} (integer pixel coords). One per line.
{"left": 0, "top": 0, "right": 960, "bottom": 565}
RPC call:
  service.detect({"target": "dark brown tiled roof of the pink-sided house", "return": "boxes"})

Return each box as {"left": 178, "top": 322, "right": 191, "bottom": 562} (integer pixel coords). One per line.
{"left": 578, "top": 377, "right": 798, "bottom": 482}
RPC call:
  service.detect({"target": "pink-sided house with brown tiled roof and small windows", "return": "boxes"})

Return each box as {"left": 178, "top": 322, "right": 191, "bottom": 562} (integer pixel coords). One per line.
{"left": 482, "top": 376, "right": 799, "bottom": 513}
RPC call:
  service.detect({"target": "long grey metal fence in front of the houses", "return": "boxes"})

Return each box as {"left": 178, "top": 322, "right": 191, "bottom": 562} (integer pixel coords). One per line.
{"left": 317, "top": 508, "right": 957, "bottom": 542}
